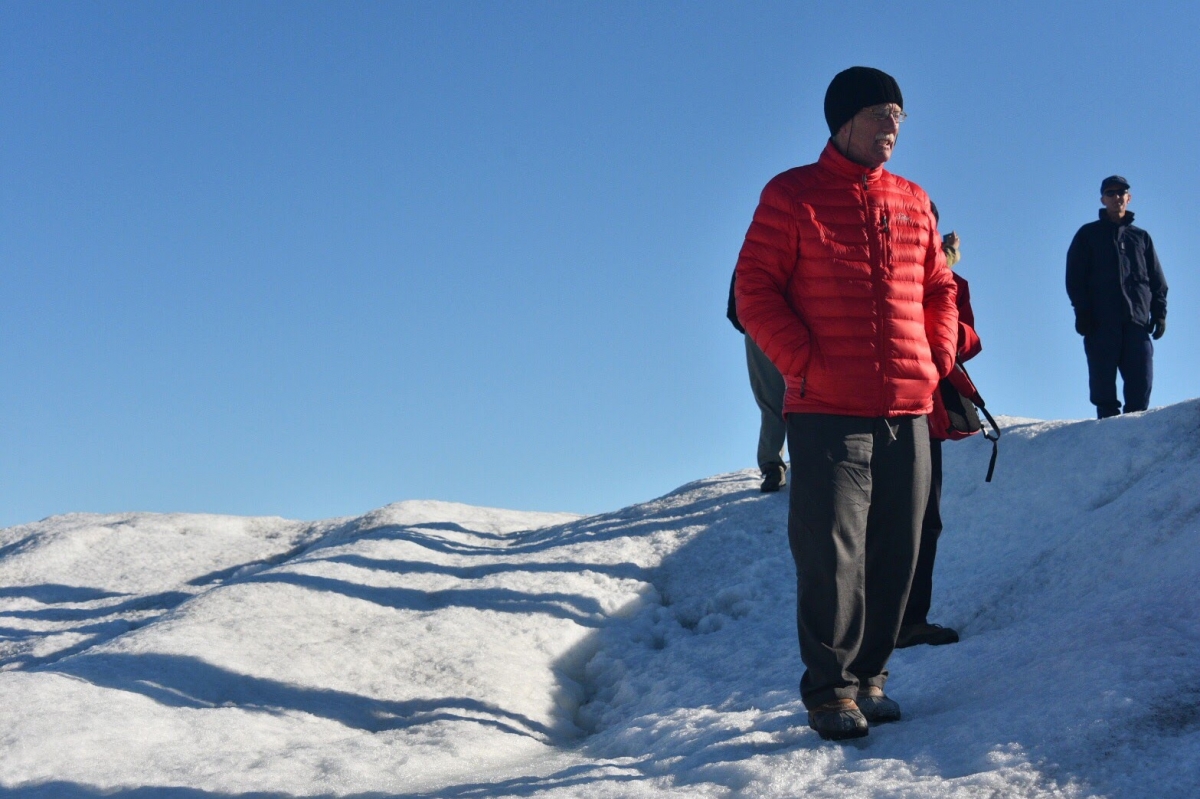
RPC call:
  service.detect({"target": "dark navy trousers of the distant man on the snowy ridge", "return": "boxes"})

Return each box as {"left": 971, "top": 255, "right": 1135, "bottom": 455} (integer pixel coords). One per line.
{"left": 1084, "top": 322, "right": 1154, "bottom": 419}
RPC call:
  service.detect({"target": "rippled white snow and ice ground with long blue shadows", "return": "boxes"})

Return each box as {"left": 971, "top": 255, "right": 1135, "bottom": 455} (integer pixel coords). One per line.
{"left": 0, "top": 401, "right": 1200, "bottom": 799}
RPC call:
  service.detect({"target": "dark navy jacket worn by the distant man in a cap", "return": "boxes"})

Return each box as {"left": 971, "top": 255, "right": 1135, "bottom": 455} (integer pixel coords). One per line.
{"left": 1067, "top": 209, "right": 1166, "bottom": 332}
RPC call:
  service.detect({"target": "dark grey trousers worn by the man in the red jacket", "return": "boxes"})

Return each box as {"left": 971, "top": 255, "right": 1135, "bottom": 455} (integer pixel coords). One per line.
{"left": 787, "top": 414, "right": 930, "bottom": 709}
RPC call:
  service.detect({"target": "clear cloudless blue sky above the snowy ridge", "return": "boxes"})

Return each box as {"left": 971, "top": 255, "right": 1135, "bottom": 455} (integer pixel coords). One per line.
{"left": 0, "top": 0, "right": 1200, "bottom": 525}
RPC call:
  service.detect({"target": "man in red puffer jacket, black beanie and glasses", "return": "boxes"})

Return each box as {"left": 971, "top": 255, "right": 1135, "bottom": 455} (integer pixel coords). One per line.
{"left": 737, "top": 67, "right": 958, "bottom": 739}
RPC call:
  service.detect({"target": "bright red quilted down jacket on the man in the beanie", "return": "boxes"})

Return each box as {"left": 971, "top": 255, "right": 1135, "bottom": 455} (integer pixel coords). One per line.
{"left": 737, "top": 142, "right": 959, "bottom": 416}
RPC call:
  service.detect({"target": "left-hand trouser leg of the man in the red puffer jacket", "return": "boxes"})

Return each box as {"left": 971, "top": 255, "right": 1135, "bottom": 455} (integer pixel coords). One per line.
{"left": 787, "top": 414, "right": 875, "bottom": 709}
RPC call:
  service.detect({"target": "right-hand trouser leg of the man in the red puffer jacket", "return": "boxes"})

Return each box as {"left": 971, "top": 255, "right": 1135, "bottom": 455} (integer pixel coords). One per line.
{"left": 850, "top": 416, "right": 931, "bottom": 687}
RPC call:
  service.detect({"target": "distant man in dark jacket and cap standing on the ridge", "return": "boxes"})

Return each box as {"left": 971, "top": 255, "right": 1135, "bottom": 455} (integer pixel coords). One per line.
{"left": 1067, "top": 175, "right": 1166, "bottom": 419}
